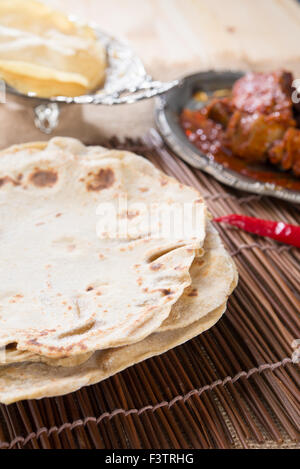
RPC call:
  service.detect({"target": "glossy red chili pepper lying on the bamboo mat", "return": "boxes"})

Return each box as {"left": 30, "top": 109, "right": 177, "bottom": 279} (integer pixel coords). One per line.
{"left": 214, "top": 214, "right": 300, "bottom": 248}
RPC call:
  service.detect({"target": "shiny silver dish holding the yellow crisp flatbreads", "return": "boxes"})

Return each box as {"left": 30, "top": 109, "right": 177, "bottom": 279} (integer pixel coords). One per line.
{"left": 7, "top": 23, "right": 178, "bottom": 106}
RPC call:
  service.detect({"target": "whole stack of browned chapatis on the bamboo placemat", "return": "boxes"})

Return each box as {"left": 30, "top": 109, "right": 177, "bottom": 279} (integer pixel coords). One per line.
{"left": 0, "top": 138, "right": 237, "bottom": 404}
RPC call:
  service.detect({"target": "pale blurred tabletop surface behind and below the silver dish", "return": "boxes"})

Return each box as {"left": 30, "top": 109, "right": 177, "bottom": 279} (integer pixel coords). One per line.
{"left": 0, "top": 0, "right": 300, "bottom": 148}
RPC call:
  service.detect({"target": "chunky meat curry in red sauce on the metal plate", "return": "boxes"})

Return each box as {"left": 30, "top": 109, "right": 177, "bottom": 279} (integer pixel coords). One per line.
{"left": 181, "top": 71, "right": 300, "bottom": 189}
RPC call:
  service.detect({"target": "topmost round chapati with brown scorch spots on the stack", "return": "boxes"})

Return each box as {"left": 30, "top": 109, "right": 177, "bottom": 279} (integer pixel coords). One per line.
{"left": 0, "top": 138, "right": 206, "bottom": 358}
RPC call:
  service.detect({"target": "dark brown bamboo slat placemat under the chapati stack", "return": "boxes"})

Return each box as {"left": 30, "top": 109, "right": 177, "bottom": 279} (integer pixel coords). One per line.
{"left": 0, "top": 131, "right": 300, "bottom": 449}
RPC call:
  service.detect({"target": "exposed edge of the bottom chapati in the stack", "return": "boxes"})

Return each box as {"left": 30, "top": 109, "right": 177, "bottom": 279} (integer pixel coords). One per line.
{"left": 0, "top": 304, "right": 226, "bottom": 404}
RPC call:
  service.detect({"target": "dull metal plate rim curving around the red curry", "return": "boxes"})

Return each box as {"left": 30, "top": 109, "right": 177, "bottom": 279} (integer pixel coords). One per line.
{"left": 156, "top": 71, "right": 300, "bottom": 203}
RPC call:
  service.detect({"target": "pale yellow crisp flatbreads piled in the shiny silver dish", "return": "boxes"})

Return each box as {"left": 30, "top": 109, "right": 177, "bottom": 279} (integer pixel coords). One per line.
{"left": 0, "top": 0, "right": 106, "bottom": 97}
